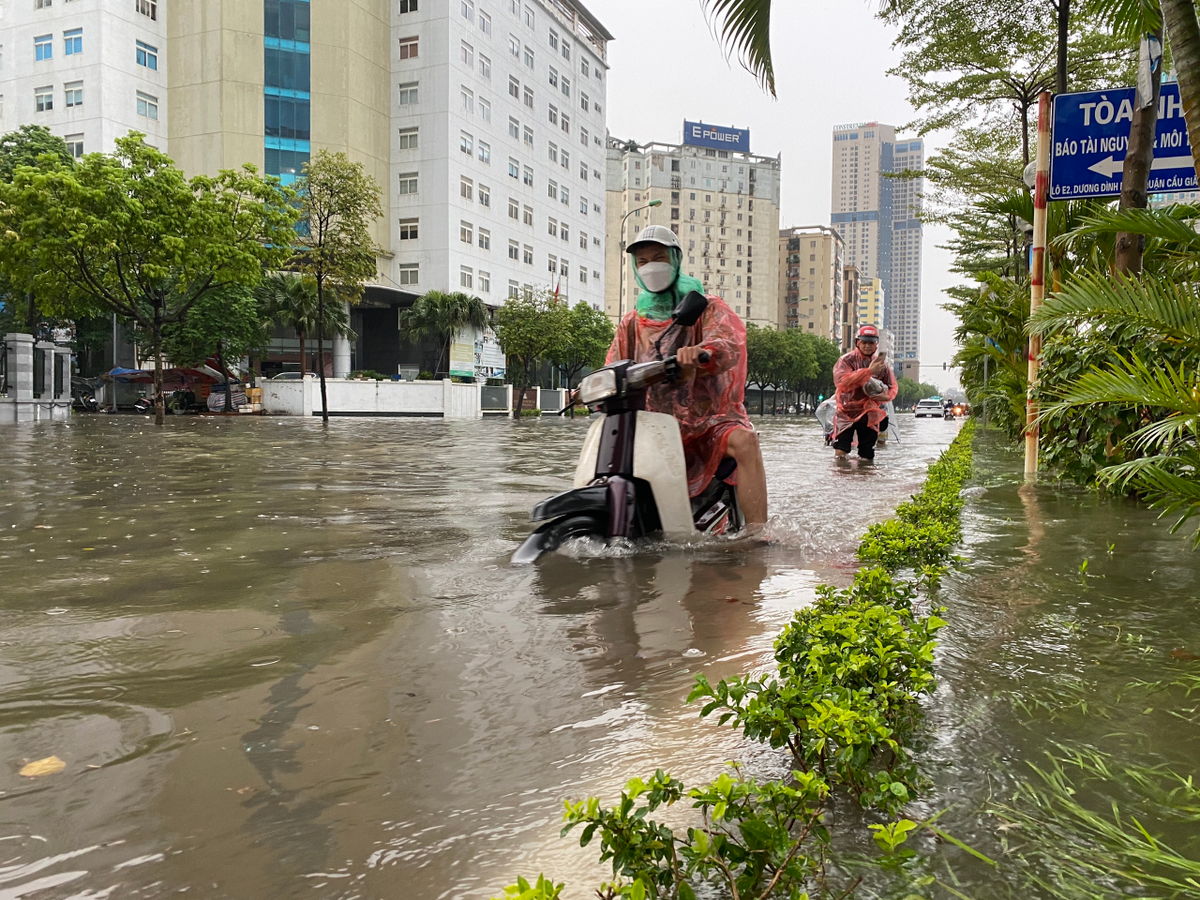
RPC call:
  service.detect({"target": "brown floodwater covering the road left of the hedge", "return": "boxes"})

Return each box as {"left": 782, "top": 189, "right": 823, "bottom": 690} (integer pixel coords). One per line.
{"left": 0, "top": 415, "right": 955, "bottom": 900}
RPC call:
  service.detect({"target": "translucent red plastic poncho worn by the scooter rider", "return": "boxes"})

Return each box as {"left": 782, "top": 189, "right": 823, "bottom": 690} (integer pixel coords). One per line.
{"left": 605, "top": 296, "right": 754, "bottom": 497}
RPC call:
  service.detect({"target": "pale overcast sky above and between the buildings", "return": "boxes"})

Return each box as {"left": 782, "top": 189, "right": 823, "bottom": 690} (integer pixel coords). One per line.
{"left": 600, "top": 0, "right": 960, "bottom": 386}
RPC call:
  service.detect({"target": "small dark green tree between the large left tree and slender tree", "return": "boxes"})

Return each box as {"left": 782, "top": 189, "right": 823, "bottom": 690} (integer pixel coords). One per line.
{"left": 163, "top": 284, "right": 271, "bottom": 413}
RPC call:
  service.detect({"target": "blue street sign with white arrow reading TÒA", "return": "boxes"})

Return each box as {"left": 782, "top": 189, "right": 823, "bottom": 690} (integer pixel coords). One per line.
{"left": 1050, "top": 83, "right": 1196, "bottom": 200}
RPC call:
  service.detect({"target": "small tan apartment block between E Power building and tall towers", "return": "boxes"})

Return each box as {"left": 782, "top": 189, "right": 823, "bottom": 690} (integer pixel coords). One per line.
{"left": 779, "top": 226, "right": 845, "bottom": 346}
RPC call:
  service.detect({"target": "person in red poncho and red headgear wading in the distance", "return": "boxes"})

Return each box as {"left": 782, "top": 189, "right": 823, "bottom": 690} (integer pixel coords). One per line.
{"left": 833, "top": 325, "right": 899, "bottom": 460}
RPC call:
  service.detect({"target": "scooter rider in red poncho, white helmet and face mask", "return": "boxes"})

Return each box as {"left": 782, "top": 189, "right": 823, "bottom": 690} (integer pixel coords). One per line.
{"left": 607, "top": 226, "right": 767, "bottom": 530}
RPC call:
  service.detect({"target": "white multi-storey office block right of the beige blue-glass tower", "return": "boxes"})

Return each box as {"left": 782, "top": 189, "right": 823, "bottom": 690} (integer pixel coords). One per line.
{"left": 391, "top": 0, "right": 612, "bottom": 310}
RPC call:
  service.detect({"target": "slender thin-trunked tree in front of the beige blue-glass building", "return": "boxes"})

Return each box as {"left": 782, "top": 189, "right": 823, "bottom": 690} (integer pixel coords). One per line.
{"left": 288, "top": 150, "right": 383, "bottom": 425}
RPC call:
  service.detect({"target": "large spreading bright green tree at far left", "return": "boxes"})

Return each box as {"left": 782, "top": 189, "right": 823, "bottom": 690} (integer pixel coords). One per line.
{"left": 0, "top": 132, "right": 296, "bottom": 425}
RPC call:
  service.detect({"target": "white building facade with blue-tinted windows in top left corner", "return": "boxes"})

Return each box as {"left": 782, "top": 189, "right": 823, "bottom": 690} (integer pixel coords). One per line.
{"left": 0, "top": 0, "right": 168, "bottom": 156}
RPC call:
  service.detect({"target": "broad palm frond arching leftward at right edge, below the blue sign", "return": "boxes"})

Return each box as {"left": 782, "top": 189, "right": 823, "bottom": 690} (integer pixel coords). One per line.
{"left": 1030, "top": 270, "right": 1200, "bottom": 343}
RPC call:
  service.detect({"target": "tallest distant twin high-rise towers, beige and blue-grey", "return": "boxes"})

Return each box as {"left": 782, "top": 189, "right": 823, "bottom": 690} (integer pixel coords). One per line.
{"left": 830, "top": 122, "right": 924, "bottom": 371}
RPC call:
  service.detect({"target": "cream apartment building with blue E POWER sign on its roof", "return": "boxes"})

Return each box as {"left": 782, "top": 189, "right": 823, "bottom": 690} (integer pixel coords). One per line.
{"left": 605, "top": 122, "right": 780, "bottom": 328}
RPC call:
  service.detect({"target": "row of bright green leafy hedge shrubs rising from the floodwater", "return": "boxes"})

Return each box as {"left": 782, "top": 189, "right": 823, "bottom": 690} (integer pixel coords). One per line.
{"left": 498, "top": 422, "right": 973, "bottom": 900}
